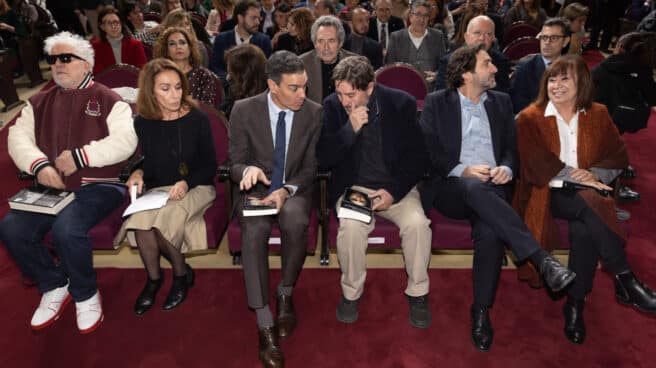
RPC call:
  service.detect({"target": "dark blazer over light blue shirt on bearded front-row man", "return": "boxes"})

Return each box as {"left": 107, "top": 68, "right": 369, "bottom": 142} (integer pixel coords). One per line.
{"left": 419, "top": 89, "right": 519, "bottom": 207}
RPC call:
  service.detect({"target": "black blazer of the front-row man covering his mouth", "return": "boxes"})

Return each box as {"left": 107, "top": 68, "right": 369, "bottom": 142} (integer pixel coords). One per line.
{"left": 317, "top": 84, "right": 427, "bottom": 206}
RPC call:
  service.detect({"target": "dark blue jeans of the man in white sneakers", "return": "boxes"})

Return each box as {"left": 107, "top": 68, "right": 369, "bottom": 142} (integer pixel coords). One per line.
{"left": 0, "top": 184, "right": 124, "bottom": 302}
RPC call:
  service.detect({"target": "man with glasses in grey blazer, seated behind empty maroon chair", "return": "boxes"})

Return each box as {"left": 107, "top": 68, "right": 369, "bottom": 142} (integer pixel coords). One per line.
{"left": 385, "top": 0, "right": 446, "bottom": 84}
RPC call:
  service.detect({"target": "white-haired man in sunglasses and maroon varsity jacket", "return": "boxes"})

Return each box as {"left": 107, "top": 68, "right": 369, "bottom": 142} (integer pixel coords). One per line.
{"left": 0, "top": 32, "right": 137, "bottom": 334}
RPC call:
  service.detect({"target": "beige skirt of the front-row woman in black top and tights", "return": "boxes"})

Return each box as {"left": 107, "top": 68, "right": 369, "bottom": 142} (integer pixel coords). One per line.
{"left": 114, "top": 185, "right": 216, "bottom": 253}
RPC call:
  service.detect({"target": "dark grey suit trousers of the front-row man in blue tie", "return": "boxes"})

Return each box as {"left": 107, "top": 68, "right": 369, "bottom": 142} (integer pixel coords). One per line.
{"left": 237, "top": 195, "right": 311, "bottom": 309}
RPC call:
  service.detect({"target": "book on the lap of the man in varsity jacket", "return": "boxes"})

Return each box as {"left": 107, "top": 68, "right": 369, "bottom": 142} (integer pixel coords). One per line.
{"left": 9, "top": 185, "right": 75, "bottom": 215}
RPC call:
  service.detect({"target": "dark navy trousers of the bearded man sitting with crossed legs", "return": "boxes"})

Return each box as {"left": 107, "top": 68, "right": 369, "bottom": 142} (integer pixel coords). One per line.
{"left": 433, "top": 178, "right": 540, "bottom": 306}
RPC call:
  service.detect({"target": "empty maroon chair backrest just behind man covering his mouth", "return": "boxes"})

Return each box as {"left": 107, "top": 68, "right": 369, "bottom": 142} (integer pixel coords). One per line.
{"left": 376, "top": 63, "right": 428, "bottom": 100}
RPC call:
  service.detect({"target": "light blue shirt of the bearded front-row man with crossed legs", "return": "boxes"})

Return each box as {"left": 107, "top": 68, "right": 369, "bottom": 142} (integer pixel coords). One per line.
{"left": 448, "top": 92, "right": 512, "bottom": 177}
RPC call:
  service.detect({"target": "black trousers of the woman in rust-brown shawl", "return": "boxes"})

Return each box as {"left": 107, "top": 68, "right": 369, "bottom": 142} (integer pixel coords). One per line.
{"left": 551, "top": 190, "right": 629, "bottom": 299}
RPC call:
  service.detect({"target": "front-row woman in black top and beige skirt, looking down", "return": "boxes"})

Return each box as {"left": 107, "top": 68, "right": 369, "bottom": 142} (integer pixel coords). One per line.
{"left": 115, "top": 58, "right": 217, "bottom": 315}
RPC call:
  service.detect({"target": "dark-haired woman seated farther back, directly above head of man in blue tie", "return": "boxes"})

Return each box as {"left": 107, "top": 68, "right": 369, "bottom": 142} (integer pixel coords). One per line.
{"left": 273, "top": 8, "right": 314, "bottom": 55}
